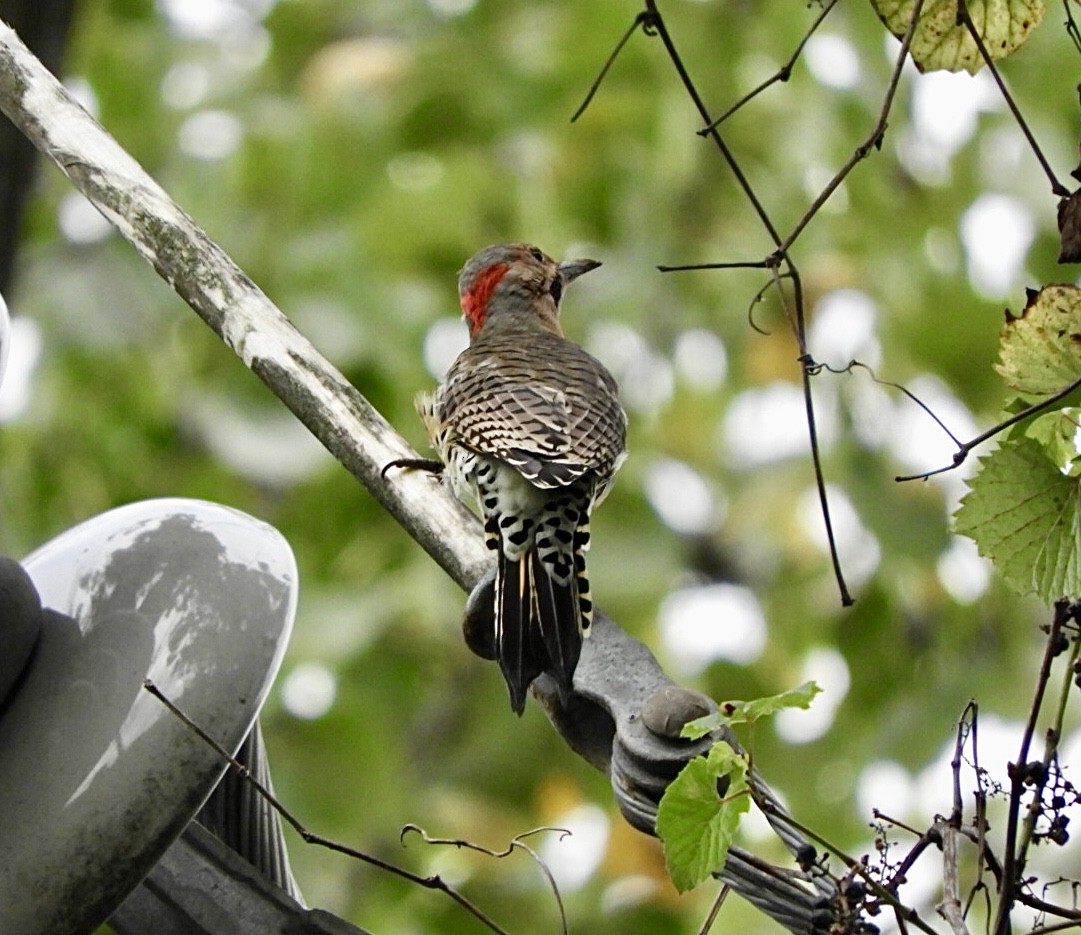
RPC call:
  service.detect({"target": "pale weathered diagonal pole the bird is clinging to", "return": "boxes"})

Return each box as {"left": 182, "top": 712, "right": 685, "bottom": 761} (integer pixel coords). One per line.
{"left": 0, "top": 21, "right": 489, "bottom": 590}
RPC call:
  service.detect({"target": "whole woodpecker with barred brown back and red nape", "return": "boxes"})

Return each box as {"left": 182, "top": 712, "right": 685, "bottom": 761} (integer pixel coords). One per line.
{"left": 417, "top": 243, "right": 627, "bottom": 714}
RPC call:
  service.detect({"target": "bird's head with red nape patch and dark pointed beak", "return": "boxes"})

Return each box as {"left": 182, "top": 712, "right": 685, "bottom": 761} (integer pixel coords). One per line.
{"left": 458, "top": 243, "right": 600, "bottom": 337}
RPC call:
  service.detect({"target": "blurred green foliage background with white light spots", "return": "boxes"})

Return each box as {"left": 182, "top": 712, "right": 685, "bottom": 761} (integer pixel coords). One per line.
{"left": 0, "top": 0, "right": 1081, "bottom": 935}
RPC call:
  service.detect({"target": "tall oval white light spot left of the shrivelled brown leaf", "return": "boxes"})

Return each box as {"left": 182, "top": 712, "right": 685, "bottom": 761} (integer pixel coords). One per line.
{"left": 961, "top": 193, "right": 1036, "bottom": 298}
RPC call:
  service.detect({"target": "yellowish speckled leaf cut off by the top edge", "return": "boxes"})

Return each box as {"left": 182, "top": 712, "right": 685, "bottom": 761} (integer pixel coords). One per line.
{"left": 871, "top": 0, "right": 1044, "bottom": 75}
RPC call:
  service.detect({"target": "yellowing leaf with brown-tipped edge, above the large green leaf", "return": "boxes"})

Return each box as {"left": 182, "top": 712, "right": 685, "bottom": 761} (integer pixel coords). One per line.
{"left": 995, "top": 284, "right": 1081, "bottom": 399}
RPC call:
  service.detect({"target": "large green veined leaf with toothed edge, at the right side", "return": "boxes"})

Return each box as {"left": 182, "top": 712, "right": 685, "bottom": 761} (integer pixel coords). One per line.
{"left": 955, "top": 439, "right": 1081, "bottom": 603}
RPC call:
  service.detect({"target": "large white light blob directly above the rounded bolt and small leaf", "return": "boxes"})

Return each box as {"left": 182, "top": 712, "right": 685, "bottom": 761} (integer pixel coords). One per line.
{"left": 657, "top": 584, "right": 766, "bottom": 677}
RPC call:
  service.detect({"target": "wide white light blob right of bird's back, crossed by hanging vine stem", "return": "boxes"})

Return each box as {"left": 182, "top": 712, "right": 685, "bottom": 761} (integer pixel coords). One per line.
{"left": 720, "top": 380, "right": 837, "bottom": 468}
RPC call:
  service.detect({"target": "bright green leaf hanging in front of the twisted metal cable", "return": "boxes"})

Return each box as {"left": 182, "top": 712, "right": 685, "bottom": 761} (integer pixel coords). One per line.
{"left": 657, "top": 740, "right": 750, "bottom": 893}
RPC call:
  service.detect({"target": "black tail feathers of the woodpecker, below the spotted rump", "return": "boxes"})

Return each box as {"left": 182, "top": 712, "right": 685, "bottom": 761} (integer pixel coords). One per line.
{"left": 495, "top": 549, "right": 582, "bottom": 714}
